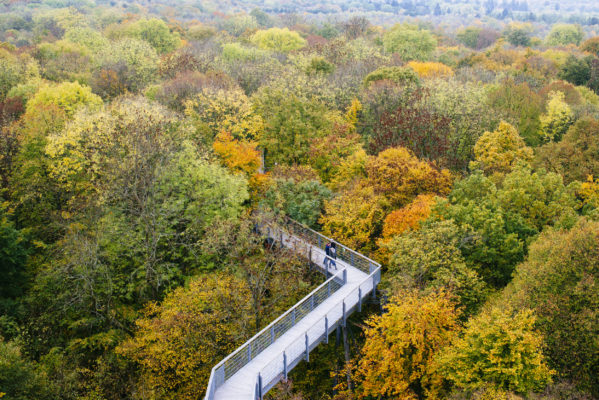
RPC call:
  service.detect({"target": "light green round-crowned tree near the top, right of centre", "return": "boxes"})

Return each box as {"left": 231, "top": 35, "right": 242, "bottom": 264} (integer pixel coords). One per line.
{"left": 383, "top": 24, "right": 437, "bottom": 61}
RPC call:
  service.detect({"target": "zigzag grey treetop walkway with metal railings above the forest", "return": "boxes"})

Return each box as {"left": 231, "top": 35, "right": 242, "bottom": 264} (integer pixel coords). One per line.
{"left": 205, "top": 220, "right": 381, "bottom": 400}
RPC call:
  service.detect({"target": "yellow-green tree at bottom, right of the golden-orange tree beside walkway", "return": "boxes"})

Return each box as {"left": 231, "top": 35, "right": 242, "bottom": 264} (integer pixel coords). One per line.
{"left": 439, "top": 308, "right": 554, "bottom": 394}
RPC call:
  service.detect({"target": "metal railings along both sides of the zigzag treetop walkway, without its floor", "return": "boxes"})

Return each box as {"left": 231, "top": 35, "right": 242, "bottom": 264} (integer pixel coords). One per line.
{"left": 205, "top": 219, "right": 381, "bottom": 400}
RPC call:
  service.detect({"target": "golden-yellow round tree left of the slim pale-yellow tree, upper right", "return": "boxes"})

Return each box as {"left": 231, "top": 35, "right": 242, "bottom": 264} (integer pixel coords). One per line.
{"left": 470, "top": 121, "right": 533, "bottom": 179}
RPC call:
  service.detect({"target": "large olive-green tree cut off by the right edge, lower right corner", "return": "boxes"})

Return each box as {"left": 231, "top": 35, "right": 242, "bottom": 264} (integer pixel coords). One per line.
{"left": 500, "top": 219, "right": 599, "bottom": 396}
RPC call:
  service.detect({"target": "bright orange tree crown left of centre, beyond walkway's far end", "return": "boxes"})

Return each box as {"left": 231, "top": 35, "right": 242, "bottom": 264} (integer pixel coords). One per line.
{"left": 212, "top": 131, "right": 260, "bottom": 175}
